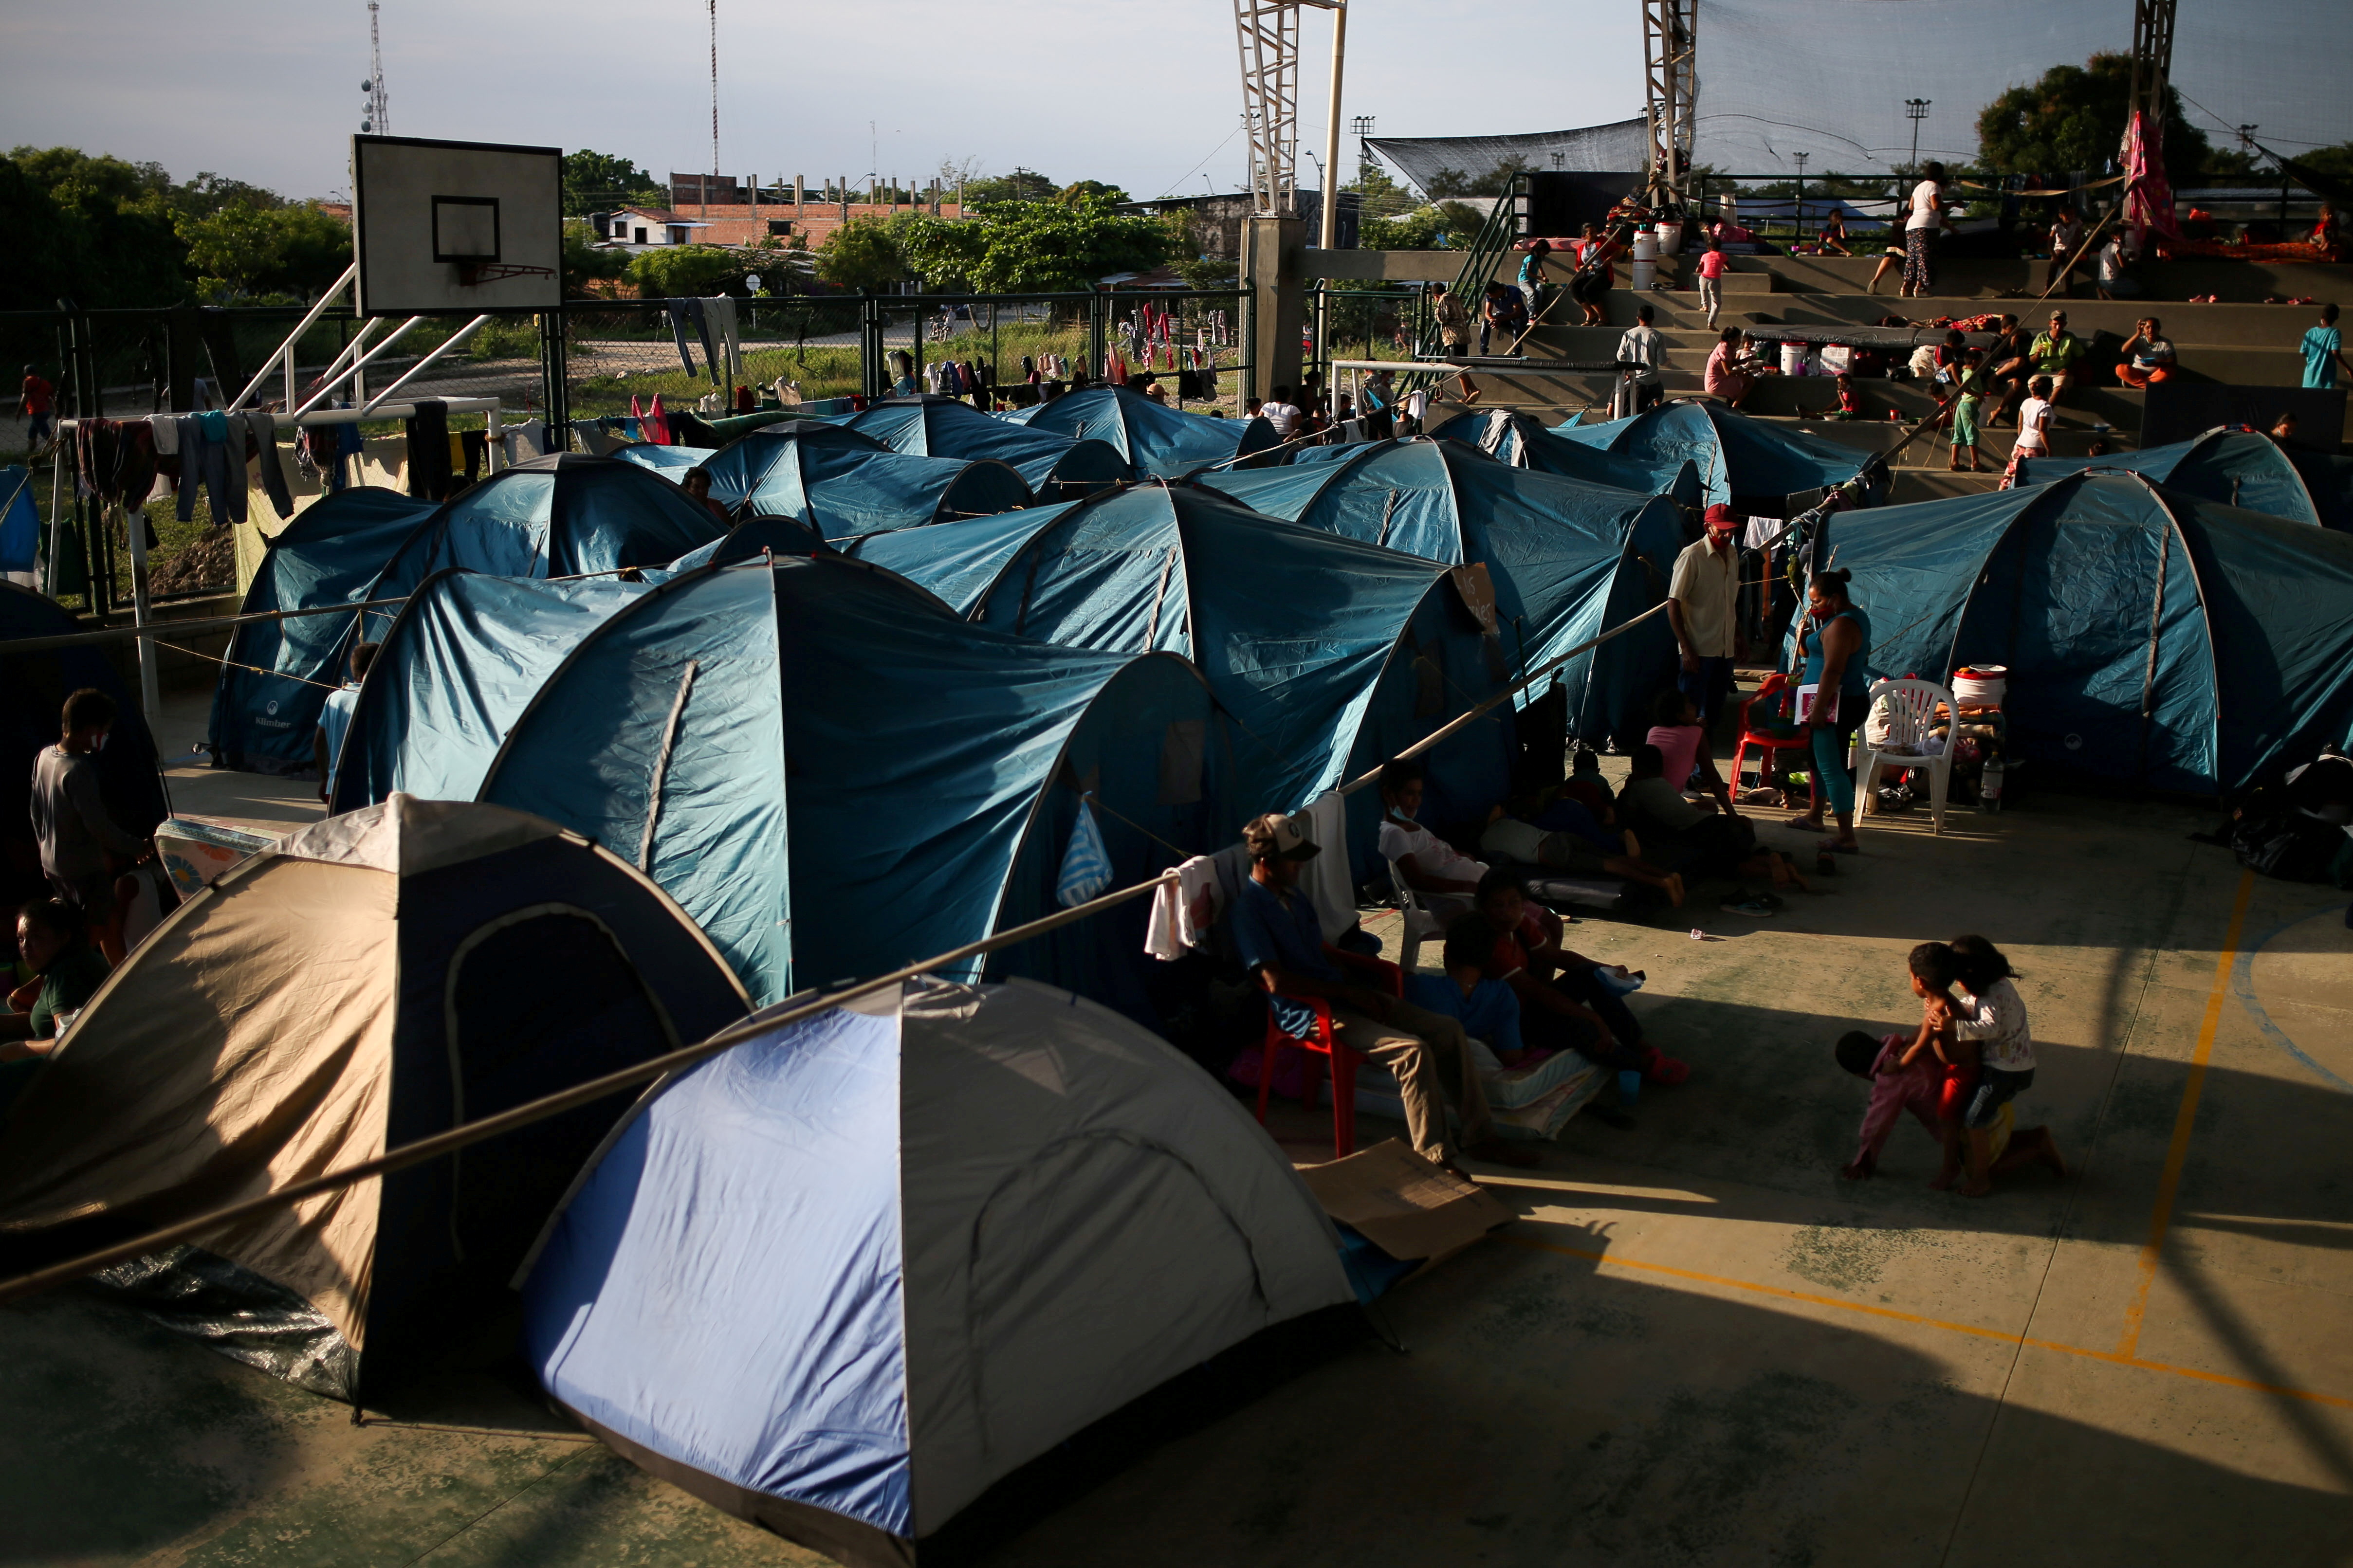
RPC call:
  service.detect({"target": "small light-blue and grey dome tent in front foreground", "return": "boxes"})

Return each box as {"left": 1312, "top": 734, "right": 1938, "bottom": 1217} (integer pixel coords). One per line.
{"left": 522, "top": 980, "right": 1355, "bottom": 1568}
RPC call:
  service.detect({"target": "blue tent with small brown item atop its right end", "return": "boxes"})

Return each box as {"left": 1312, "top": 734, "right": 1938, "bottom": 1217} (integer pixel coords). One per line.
{"left": 857, "top": 484, "right": 1513, "bottom": 865}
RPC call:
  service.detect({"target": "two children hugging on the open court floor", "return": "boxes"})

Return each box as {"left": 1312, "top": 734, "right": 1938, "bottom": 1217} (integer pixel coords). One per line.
{"left": 1838, "top": 936, "right": 2066, "bottom": 1197}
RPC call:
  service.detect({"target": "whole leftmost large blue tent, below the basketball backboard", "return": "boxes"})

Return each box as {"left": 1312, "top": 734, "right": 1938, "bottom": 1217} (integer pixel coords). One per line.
{"left": 212, "top": 451, "right": 727, "bottom": 773}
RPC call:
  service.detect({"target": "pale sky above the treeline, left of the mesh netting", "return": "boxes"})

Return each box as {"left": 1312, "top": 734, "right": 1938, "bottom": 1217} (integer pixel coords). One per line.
{"left": 0, "top": 0, "right": 1642, "bottom": 198}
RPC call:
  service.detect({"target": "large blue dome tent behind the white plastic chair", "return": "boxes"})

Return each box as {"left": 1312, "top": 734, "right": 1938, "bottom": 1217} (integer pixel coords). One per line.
{"left": 1826, "top": 475, "right": 2353, "bottom": 795}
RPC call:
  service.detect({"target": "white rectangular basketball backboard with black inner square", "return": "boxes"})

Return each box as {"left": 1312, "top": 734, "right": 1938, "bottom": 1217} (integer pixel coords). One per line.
{"left": 350, "top": 136, "right": 565, "bottom": 315}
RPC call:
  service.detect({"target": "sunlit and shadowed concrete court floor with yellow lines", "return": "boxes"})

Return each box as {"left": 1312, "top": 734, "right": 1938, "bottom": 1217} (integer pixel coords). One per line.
{"left": 0, "top": 691, "right": 2353, "bottom": 1568}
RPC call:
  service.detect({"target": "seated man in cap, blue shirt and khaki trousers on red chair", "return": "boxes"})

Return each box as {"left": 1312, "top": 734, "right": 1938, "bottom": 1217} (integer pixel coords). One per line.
{"left": 1231, "top": 813, "right": 1537, "bottom": 1166}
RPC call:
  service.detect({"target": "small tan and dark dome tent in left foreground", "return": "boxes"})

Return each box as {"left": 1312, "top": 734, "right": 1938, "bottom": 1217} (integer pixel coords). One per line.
{"left": 0, "top": 795, "right": 748, "bottom": 1401}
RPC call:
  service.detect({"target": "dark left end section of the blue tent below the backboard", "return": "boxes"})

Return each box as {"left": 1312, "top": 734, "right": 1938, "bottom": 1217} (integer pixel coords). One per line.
{"left": 212, "top": 489, "right": 435, "bottom": 773}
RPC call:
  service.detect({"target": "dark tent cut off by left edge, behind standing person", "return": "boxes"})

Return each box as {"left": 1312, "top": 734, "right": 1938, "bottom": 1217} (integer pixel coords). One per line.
{"left": 0, "top": 583, "right": 170, "bottom": 902}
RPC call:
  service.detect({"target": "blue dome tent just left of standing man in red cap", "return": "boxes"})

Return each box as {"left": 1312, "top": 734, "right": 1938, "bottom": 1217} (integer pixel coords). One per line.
{"left": 1200, "top": 439, "right": 1682, "bottom": 741}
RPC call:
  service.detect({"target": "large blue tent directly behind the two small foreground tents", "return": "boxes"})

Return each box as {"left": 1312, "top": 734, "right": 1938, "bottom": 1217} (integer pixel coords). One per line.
{"left": 360, "top": 557, "right": 1231, "bottom": 999}
